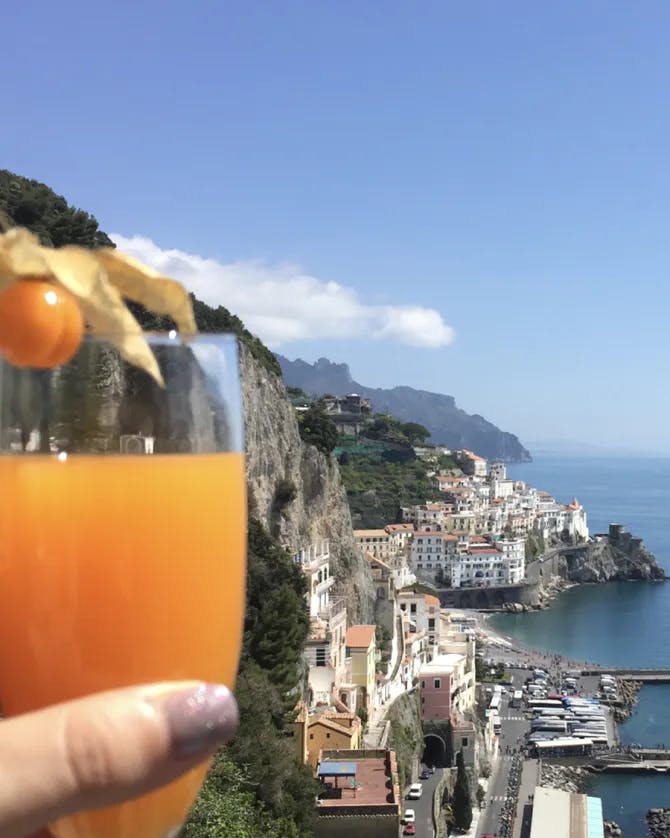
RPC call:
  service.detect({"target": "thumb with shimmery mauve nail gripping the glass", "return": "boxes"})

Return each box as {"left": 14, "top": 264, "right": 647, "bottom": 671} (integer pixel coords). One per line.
{"left": 0, "top": 682, "right": 238, "bottom": 838}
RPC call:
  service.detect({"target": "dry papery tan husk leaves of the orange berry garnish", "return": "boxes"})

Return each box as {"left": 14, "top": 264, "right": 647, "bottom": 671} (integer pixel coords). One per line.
{"left": 0, "top": 227, "right": 197, "bottom": 386}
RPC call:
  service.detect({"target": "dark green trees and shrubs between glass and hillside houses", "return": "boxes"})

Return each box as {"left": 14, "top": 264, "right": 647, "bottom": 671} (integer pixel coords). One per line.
{"left": 184, "top": 518, "right": 318, "bottom": 838}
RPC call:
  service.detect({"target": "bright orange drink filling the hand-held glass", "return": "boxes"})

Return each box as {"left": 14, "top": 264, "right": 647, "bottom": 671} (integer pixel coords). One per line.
{"left": 0, "top": 453, "right": 246, "bottom": 838}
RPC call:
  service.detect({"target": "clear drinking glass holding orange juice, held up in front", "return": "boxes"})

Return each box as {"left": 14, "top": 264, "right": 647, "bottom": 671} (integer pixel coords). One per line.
{"left": 0, "top": 332, "right": 246, "bottom": 838}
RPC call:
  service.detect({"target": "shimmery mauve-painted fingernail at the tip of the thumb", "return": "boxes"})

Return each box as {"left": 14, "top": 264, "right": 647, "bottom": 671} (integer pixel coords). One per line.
{"left": 162, "top": 684, "right": 239, "bottom": 757}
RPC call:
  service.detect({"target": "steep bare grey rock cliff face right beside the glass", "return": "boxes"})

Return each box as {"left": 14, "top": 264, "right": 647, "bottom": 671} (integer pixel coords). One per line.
{"left": 240, "top": 346, "right": 374, "bottom": 622}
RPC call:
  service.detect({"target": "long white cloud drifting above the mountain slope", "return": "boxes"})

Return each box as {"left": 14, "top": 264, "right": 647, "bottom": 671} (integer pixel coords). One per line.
{"left": 111, "top": 234, "right": 454, "bottom": 349}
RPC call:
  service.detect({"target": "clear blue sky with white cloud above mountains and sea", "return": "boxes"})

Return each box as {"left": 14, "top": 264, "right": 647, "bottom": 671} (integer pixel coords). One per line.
{"left": 0, "top": 0, "right": 670, "bottom": 451}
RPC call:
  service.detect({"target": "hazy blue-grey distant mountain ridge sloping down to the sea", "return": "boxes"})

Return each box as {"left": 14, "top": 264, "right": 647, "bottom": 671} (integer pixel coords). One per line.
{"left": 277, "top": 355, "right": 532, "bottom": 462}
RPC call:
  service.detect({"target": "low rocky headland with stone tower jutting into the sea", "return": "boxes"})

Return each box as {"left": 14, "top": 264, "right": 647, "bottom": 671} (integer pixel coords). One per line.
{"left": 561, "top": 533, "right": 665, "bottom": 582}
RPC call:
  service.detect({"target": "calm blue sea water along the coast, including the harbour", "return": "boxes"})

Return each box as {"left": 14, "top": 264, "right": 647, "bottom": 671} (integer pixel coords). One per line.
{"left": 492, "top": 454, "right": 670, "bottom": 838}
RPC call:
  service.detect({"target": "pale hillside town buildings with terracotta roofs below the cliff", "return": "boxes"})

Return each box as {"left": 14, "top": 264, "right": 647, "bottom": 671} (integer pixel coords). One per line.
{"left": 293, "top": 442, "right": 600, "bottom": 838}
